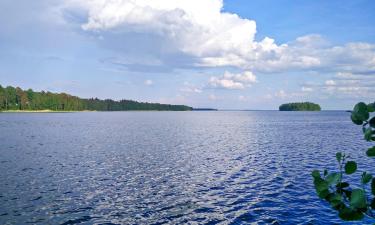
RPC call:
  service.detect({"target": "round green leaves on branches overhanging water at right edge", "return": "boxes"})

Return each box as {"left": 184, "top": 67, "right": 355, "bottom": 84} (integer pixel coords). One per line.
{"left": 312, "top": 102, "right": 375, "bottom": 221}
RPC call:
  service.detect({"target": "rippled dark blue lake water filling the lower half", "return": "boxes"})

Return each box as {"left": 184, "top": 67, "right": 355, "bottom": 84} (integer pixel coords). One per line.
{"left": 0, "top": 111, "right": 375, "bottom": 224}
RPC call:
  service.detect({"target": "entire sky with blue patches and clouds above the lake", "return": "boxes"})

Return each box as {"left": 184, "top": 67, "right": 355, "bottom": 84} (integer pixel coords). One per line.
{"left": 0, "top": 0, "right": 375, "bottom": 110}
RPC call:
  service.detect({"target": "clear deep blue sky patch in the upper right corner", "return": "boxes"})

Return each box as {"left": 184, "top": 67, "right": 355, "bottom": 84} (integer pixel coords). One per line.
{"left": 224, "top": 0, "right": 375, "bottom": 44}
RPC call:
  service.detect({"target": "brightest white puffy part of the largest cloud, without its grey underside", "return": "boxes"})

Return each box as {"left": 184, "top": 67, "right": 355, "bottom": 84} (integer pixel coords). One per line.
{"left": 62, "top": 0, "right": 262, "bottom": 66}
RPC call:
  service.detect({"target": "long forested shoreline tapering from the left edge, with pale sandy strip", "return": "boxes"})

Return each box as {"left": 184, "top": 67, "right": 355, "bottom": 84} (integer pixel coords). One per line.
{"left": 0, "top": 85, "right": 193, "bottom": 111}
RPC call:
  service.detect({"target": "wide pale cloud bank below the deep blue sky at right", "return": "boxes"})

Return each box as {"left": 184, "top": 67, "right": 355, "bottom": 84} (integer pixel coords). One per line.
{"left": 250, "top": 35, "right": 375, "bottom": 73}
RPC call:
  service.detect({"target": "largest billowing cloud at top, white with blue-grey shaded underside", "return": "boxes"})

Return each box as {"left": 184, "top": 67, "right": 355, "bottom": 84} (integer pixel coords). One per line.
{"left": 58, "top": 0, "right": 290, "bottom": 71}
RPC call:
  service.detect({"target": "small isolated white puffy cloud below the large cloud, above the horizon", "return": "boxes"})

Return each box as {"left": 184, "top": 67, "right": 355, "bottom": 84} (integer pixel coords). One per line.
{"left": 209, "top": 71, "right": 257, "bottom": 89}
